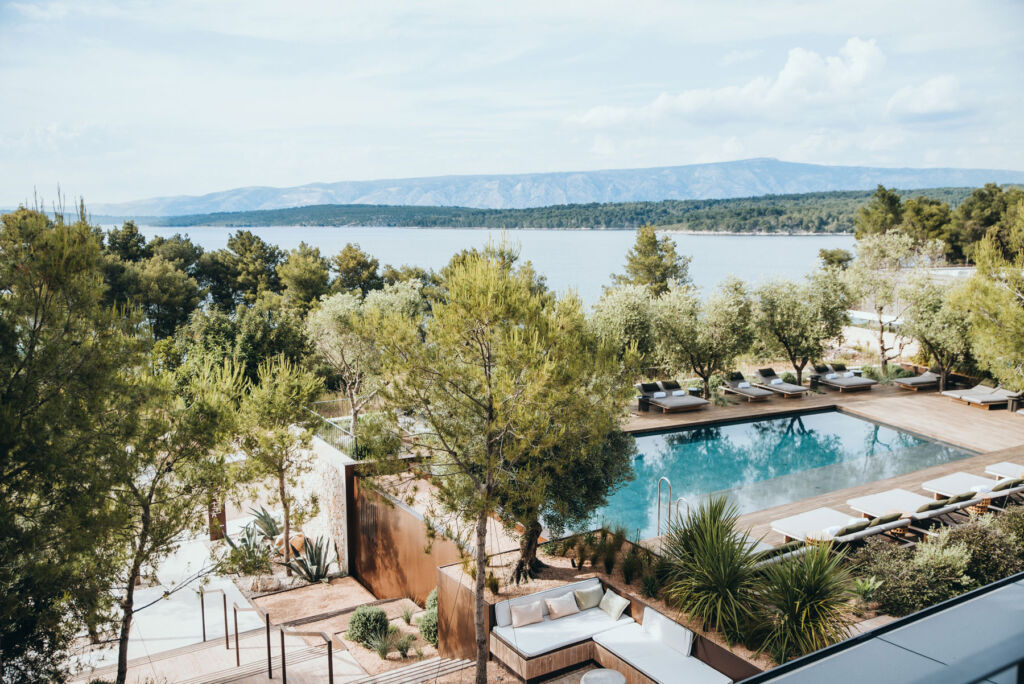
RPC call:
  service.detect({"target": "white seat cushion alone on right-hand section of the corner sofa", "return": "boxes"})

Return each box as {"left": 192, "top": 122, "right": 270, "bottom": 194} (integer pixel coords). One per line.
{"left": 594, "top": 621, "right": 732, "bottom": 684}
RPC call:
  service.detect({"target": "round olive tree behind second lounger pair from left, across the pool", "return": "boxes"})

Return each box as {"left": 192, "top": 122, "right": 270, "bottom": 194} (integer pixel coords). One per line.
{"left": 754, "top": 268, "right": 849, "bottom": 384}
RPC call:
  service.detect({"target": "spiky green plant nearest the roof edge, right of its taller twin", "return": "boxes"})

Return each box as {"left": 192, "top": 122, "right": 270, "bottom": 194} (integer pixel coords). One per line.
{"left": 760, "top": 545, "right": 853, "bottom": 662}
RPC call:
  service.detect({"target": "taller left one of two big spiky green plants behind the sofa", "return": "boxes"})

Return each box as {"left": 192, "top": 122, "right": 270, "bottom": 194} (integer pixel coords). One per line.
{"left": 662, "top": 497, "right": 759, "bottom": 643}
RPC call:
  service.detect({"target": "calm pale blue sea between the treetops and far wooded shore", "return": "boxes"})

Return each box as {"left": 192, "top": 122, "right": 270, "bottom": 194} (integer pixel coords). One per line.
{"left": 141, "top": 226, "right": 854, "bottom": 304}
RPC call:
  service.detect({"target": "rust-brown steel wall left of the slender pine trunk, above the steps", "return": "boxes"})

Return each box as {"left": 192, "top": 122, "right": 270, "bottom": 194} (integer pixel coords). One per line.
{"left": 346, "top": 473, "right": 461, "bottom": 605}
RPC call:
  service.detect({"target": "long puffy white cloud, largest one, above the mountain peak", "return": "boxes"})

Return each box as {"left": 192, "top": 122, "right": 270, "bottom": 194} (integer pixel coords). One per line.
{"left": 578, "top": 37, "right": 885, "bottom": 126}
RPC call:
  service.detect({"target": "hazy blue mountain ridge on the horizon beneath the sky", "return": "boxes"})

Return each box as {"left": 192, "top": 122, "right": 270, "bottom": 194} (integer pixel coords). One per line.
{"left": 90, "top": 159, "right": 1024, "bottom": 216}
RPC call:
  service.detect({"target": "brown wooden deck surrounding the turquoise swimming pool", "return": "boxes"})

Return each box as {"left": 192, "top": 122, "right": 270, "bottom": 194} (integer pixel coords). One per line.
{"left": 625, "top": 385, "right": 1024, "bottom": 545}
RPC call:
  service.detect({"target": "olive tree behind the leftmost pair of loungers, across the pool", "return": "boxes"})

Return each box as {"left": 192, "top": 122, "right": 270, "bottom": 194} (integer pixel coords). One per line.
{"left": 653, "top": 279, "right": 754, "bottom": 398}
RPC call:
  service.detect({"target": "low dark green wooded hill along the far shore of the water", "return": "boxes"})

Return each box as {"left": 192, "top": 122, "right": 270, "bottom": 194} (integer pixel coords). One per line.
{"left": 148, "top": 187, "right": 973, "bottom": 232}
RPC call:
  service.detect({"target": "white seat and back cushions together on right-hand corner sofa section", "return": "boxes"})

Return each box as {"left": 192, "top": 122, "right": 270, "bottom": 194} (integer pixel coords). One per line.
{"left": 594, "top": 608, "right": 732, "bottom": 684}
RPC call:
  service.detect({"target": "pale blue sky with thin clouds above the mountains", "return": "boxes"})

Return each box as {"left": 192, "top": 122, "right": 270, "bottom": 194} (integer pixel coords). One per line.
{"left": 0, "top": 0, "right": 1024, "bottom": 206}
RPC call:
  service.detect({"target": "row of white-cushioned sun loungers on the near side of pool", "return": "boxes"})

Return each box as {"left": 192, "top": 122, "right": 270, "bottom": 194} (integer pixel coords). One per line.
{"left": 771, "top": 462, "right": 1024, "bottom": 544}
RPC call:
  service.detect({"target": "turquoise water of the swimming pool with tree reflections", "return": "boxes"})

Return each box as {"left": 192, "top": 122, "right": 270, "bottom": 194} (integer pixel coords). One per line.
{"left": 598, "top": 411, "right": 972, "bottom": 539}
